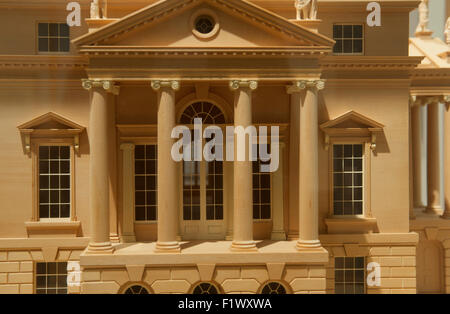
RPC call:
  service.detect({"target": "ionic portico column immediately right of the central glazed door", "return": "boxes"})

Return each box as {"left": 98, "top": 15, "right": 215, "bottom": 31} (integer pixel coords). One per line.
{"left": 230, "top": 81, "right": 258, "bottom": 251}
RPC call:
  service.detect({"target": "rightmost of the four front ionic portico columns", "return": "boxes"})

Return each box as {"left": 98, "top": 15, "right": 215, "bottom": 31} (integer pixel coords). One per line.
{"left": 291, "top": 80, "right": 325, "bottom": 250}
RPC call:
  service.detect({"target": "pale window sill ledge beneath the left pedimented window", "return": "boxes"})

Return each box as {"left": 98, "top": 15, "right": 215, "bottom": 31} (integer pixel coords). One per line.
{"left": 25, "top": 221, "right": 81, "bottom": 238}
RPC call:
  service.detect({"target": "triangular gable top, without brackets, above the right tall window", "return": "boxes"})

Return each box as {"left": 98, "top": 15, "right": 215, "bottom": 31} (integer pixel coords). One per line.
{"left": 320, "top": 110, "right": 384, "bottom": 131}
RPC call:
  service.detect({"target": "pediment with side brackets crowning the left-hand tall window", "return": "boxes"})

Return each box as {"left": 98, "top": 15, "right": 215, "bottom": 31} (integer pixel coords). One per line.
{"left": 17, "top": 112, "right": 86, "bottom": 153}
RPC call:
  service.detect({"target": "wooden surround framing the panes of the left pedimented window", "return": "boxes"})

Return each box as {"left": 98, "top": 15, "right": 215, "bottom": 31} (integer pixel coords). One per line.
{"left": 31, "top": 138, "right": 77, "bottom": 223}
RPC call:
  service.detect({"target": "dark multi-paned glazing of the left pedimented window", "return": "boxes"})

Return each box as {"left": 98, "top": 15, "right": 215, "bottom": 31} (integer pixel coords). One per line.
{"left": 39, "top": 145, "right": 71, "bottom": 219}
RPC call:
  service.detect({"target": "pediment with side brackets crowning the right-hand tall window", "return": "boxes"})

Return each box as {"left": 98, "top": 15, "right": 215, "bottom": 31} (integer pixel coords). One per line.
{"left": 320, "top": 110, "right": 384, "bottom": 150}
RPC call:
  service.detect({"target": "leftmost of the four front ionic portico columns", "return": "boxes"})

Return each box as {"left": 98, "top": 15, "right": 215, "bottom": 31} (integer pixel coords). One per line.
{"left": 83, "top": 80, "right": 118, "bottom": 254}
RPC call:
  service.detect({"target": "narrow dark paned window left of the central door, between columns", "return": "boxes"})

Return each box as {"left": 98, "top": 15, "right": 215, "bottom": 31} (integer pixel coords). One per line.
{"left": 134, "top": 145, "right": 158, "bottom": 221}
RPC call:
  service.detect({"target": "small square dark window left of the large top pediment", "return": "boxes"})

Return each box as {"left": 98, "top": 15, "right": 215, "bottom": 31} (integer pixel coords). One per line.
{"left": 38, "top": 23, "right": 70, "bottom": 53}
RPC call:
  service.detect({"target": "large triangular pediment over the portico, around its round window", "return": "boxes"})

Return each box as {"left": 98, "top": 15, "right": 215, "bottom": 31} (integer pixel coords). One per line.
{"left": 74, "top": 0, "right": 334, "bottom": 50}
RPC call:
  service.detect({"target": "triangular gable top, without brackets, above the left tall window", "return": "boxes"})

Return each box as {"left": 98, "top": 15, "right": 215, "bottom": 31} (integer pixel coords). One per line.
{"left": 17, "top": 112, "right": 85, "bottom": 133}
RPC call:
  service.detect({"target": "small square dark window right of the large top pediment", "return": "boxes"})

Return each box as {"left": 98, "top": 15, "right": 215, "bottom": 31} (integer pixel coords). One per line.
{"left": 333, "top": 24, "right": 364, "bottom": 55}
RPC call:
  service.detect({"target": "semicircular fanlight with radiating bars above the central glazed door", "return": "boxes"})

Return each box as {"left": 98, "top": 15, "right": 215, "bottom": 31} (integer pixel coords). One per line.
{"left": 180, "top": 101, "right": 225, "bottom": 124}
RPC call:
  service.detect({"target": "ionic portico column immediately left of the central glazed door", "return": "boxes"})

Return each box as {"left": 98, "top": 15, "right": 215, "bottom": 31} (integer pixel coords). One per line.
{"left": 152, "top": 81, "right": 180, "bottom": 253}
